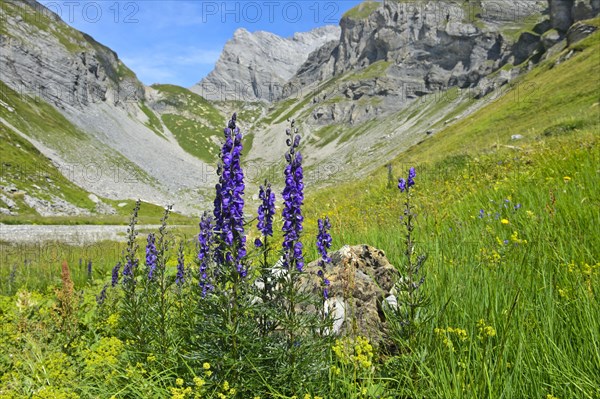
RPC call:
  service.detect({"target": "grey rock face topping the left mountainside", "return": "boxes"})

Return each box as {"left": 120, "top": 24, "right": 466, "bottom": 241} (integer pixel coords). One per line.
{"left": 0, "top": 0, "right": 144, "bottom": 108}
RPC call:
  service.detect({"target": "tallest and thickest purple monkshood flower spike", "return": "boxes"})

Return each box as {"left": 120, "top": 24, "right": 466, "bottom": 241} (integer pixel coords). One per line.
{"left": 213, "top": 114, "right": 247, "bottom": 277}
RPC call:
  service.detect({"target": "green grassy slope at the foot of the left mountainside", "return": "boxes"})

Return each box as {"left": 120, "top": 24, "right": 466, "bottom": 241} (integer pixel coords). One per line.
{"left": 0, "top": 82, "right": 189, "bottom": 224}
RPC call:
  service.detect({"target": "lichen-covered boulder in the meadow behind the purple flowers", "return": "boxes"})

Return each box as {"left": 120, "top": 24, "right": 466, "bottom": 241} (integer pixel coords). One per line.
{"left": 304, "top": 245, "right": 399, "bottom": 342}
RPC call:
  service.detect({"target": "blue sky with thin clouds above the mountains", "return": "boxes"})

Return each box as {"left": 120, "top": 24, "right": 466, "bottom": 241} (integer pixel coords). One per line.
{"left": 39, "top": 0, "right": 361, "bottom": 87}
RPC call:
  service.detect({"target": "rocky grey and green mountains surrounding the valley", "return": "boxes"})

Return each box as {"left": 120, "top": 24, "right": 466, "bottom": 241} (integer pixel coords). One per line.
{"left": 0, "top": 0, "right": 600, "bottom": 218}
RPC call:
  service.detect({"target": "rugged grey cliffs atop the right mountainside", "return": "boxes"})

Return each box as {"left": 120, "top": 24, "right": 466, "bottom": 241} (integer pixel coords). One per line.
{"left": 281, "top": 0, "right": 548, "bottom": 126}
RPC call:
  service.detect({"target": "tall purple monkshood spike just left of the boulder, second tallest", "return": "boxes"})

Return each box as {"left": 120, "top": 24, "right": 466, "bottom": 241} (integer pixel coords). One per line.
{"left": 282, "top": 121, "right": 304, "bottom": 272}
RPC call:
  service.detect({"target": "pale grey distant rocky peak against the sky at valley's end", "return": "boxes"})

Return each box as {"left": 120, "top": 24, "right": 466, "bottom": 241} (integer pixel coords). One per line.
{"left": 191, "top": 26, "right": 340, "bottom": 101}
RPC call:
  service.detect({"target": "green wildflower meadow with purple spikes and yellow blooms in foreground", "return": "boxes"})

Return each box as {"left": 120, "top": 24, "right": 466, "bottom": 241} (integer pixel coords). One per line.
{"left": 0, "top": 110, "right": 600, "bottom": 399}
